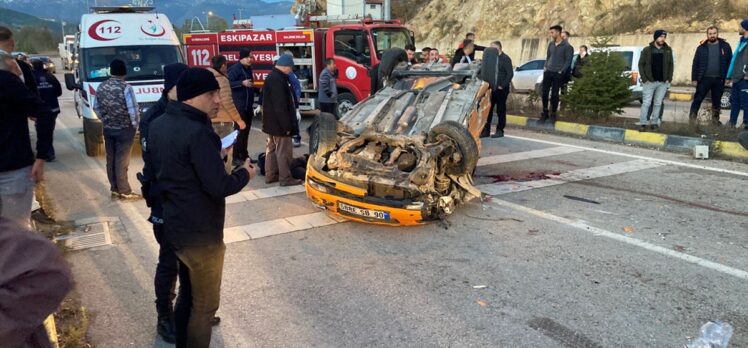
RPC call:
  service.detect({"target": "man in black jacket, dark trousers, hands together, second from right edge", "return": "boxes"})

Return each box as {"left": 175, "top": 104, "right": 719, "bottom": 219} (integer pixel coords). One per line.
{"left": 688, "top": 26, "right": 732, "bottom": 125}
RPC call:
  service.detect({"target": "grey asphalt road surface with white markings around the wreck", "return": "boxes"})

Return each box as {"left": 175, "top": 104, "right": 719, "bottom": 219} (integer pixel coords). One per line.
{"left": 45, "top": 69, "right": 748, "bottom": 347}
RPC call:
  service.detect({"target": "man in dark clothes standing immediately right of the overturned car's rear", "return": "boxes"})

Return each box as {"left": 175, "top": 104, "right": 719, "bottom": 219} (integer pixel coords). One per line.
{"left": 481, "top": 41, "right": 514, "bottom": 138}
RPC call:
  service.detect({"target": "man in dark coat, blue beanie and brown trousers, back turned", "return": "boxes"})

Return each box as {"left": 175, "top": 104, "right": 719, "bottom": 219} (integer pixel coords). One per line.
{"left": 262, "top": 54, "right": 302, "bottom": 186}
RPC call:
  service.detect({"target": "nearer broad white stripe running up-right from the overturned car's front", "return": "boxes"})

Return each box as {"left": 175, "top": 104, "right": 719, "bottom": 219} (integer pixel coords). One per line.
{"left": 477, "top": 160, "right": 665, "bottom": 195}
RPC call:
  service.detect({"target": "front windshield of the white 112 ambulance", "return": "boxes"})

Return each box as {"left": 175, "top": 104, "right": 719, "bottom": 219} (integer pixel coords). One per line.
{"left": 79, "top": 45, "right": 184, "bottom": 82}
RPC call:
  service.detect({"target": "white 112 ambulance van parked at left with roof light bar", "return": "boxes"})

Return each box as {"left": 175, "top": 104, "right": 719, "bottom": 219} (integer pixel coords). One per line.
{"left": 65, "top": 6, "right": 184, "bottom": 156}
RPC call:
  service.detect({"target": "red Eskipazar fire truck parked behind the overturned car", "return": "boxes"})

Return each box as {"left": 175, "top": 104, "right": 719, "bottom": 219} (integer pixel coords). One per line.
{"left": 183, "top": 19, "right": 415, "bottom": 115}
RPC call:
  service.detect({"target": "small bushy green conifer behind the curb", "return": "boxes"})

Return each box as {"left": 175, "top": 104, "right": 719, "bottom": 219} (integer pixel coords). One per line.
{"left": 561, "top": 46, "right": 631, "bottom": 118}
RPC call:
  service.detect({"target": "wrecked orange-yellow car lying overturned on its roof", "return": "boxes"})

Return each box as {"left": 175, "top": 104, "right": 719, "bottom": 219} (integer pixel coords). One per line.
{"left": 305, "top": 49, "right": 496, "bottom": 226}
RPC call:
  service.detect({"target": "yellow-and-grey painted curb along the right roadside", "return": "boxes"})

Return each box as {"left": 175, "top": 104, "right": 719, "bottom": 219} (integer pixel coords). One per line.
{"left": 506, "top": 115, "right": 748, "bottom": 160}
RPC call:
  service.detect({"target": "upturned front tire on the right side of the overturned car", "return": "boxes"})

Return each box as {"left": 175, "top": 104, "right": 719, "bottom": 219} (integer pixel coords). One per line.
{"left": 428, "top": 121, "right": 480, "bottom": 175}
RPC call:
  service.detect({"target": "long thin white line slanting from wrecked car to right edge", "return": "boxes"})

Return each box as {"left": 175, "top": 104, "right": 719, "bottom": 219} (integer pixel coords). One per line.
{"left": 491, "top": 199, "right": 748, "bottom": 280}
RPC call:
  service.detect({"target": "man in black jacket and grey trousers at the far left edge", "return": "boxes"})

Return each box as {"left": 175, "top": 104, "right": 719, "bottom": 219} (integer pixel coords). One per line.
{"left": 0, "top": 33, "right": 52, "bottom": 227}
